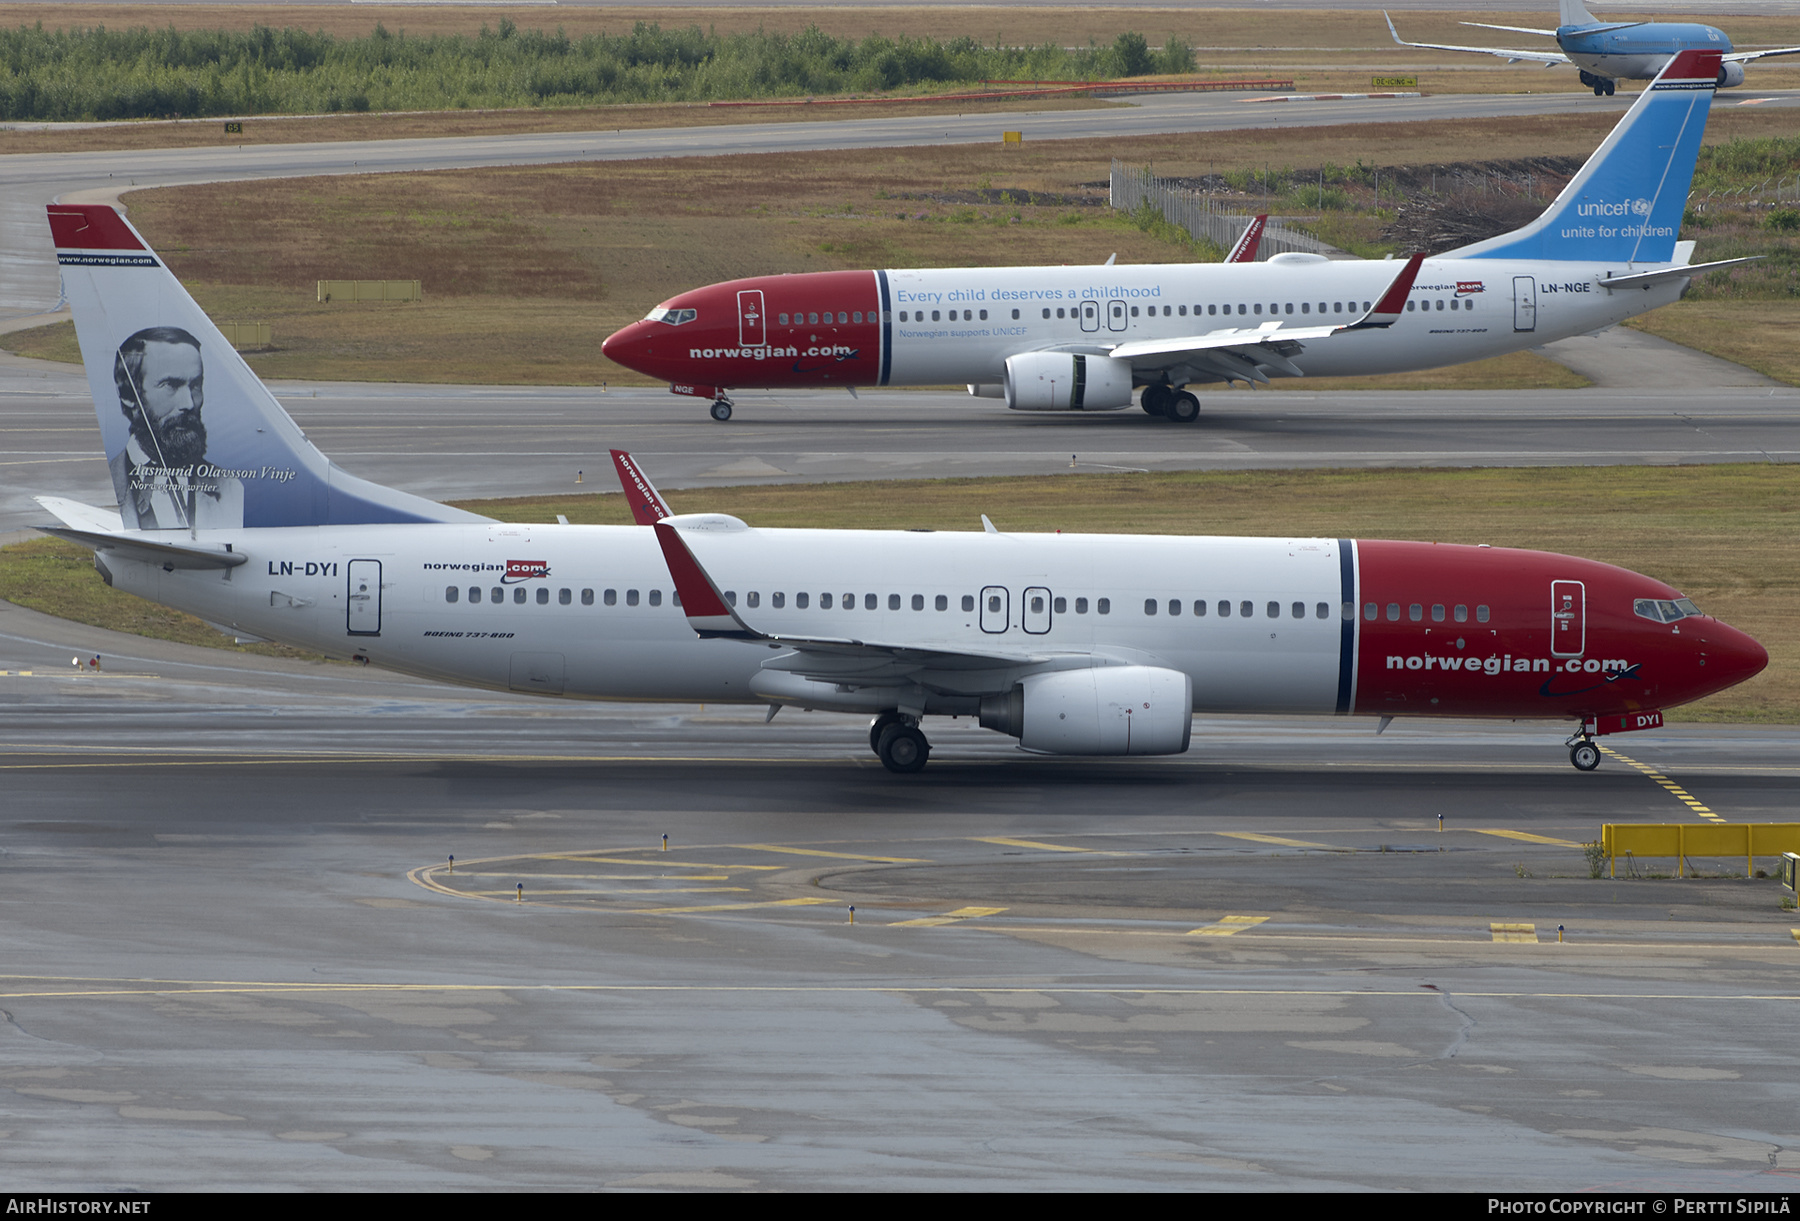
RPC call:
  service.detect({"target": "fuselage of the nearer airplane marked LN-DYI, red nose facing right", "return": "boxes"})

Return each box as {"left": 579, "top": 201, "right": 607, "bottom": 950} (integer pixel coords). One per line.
{"left": 103, "top": 524, "right": 1766, "bottom": 720}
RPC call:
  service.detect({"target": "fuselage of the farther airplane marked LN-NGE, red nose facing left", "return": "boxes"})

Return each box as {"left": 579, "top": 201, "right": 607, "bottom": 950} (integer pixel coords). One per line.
{"left": 605, "top": 259, "right": 1681, "bottom": 394}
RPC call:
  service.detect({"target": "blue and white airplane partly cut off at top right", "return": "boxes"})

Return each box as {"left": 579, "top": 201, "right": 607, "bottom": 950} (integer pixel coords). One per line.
{"left": 1382, "top": 0, "right": 1800, "bottom": 97}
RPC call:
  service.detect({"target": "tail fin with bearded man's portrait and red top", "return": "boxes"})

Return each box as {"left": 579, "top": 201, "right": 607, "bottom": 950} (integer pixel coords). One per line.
{"left": 49, "top": 204, "right": 488, "bottom": 529}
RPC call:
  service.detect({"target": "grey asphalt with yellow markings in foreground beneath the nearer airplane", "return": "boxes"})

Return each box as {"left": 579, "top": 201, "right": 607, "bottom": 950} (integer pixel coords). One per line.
{"left": 0, "top": 607, "right": 1800, "bottom": 1192}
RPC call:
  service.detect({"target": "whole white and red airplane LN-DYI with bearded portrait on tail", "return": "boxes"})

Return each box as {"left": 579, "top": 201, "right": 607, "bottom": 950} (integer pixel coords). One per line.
{"left": 40, "top": 205, "right": 1768, "bottom": 773}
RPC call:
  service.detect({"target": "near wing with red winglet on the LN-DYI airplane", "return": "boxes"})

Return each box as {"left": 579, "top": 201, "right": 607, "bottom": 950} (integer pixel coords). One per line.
{"left": 655, "top": 515, "right": 1058, "bottom": 686}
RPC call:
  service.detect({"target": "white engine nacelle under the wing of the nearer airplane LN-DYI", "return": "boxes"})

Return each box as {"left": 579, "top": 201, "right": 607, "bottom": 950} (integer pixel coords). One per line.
{"left": 981, "top": 666, "right": 1193, "bottom": 755}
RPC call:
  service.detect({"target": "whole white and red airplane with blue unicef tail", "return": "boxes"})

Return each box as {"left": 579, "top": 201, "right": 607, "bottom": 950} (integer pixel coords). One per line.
{"left": 601, "top": 50, "right": 1739, "bottom": 421}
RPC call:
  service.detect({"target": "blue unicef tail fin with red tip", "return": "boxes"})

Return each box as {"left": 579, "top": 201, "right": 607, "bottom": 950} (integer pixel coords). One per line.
{"left": 1440, "top": 50, "right": 1719, "bottom": 263}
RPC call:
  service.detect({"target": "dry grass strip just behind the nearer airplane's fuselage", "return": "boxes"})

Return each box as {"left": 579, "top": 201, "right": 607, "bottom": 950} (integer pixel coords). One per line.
{"left": 453, "top": 465, "right": 1800, "bottom": 724}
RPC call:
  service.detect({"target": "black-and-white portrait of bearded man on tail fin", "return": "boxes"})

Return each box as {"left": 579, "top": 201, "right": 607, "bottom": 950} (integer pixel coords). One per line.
{"left": 106, "top": 326, "right": 243, "bottom": 529}
